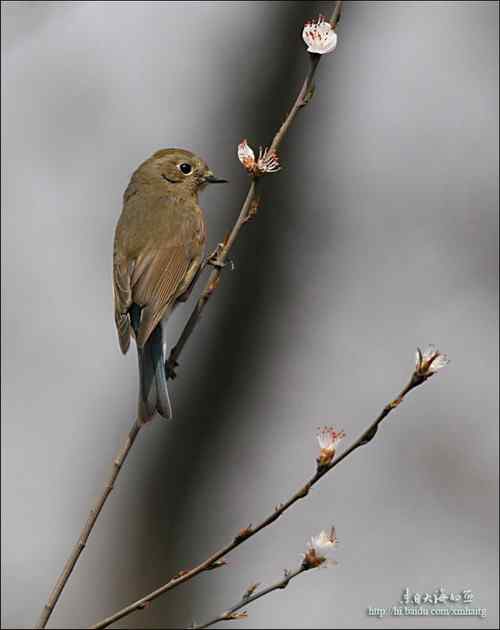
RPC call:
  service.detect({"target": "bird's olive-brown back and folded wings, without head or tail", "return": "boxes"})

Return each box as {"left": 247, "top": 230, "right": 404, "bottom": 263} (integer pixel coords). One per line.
{"left": 113, "top": 193, "right": 204, "bottom": 352}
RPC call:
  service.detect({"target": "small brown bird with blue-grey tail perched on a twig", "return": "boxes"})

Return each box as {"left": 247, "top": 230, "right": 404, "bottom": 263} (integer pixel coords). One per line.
{"left": 113, "top": 148, "right": 227, "bottom": 424}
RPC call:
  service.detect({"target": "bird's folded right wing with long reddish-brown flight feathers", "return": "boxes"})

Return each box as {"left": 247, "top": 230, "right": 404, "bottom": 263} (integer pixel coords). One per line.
{"left": 130, "top": 242, "right": 192, "bottom": 347}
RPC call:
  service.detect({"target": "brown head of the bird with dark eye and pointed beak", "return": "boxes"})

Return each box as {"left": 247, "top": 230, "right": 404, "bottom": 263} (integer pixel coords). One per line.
{"left": 139, "top": 149, "right": 227, "bottom": 194}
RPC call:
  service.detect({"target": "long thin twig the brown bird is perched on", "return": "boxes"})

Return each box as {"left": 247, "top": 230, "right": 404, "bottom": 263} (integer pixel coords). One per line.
{"left": 36, "top": 1, "right": 343, "bottom": 629}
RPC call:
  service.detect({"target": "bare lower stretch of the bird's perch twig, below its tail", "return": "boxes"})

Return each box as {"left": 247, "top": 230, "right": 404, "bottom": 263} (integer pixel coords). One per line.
{"left": 36, "top": 422, "right": 141, "bottom": 628}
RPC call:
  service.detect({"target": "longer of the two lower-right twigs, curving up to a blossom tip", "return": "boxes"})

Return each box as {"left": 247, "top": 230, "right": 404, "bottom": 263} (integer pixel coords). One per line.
{"left": 91, "top": 372, "right": 427, "bottom": 630}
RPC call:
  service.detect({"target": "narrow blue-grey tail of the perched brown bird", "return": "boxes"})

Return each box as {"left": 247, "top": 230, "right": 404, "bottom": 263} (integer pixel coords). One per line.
{"left": 130, "top": 305, "right": 172, "bottom": 422}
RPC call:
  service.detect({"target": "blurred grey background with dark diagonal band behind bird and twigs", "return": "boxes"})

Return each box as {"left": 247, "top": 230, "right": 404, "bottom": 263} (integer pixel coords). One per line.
{"left": 2, "top": 2, "right": 498, "bottom": 628}
